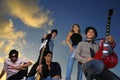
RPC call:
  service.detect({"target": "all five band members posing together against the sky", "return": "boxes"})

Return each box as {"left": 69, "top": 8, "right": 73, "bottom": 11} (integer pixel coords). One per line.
{"left": 0, "top": 24, "right": 120, "bottom": 80}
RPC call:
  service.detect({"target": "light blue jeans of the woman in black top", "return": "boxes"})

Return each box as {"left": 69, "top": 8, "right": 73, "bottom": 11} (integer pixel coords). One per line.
{"left": 66, "top": 46, "right": 82, "bottom": 80}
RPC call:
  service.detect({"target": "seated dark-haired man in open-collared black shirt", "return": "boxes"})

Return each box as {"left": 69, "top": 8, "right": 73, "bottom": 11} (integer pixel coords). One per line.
{"left": 36, "top": 51, "right": 61, "bottom": 80}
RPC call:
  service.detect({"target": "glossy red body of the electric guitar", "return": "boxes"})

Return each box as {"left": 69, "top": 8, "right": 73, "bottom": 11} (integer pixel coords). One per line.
{"left": 94, "top": 40, "right": 118, "bottom": 68}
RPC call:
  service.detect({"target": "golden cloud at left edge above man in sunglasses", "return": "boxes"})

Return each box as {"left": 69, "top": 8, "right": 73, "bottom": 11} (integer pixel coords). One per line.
{"left": 0, "top": 18, "right": 25, "bottom": 53}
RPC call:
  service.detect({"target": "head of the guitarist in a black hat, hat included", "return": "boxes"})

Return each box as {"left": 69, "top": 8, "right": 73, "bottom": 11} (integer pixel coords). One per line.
{"left": 85, "top": 26, "right": 97, "bottom": 40}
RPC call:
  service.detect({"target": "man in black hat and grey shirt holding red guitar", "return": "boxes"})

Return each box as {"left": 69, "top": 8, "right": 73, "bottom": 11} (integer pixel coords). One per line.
{"left": 75, "top": 26, "right": 120, "bottom": 80}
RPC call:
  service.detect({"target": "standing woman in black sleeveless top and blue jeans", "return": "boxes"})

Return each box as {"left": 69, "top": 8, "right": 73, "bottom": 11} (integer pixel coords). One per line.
{"left": 66, "top": 24, "right": 82, "bottom": 80}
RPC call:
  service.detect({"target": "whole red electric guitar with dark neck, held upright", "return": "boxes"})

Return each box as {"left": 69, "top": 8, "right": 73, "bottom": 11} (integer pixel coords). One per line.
{"left": 95, "top": 9, "right": 118, "bottom": 68}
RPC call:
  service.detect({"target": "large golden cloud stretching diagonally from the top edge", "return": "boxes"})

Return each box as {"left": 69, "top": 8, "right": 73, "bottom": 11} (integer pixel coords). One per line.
{"left": 4, "top": 0, "right": 53, "bottom": 28}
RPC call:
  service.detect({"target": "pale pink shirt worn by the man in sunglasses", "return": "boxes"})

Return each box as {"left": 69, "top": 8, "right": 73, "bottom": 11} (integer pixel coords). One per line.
{"left": 3, "top": 58, "right": 28, "bottom": 78}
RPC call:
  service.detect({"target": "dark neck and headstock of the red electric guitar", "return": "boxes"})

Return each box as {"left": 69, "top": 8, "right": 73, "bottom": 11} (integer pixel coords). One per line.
{"left": 106, "top": 9, "right": 114, "bottom": 36}
